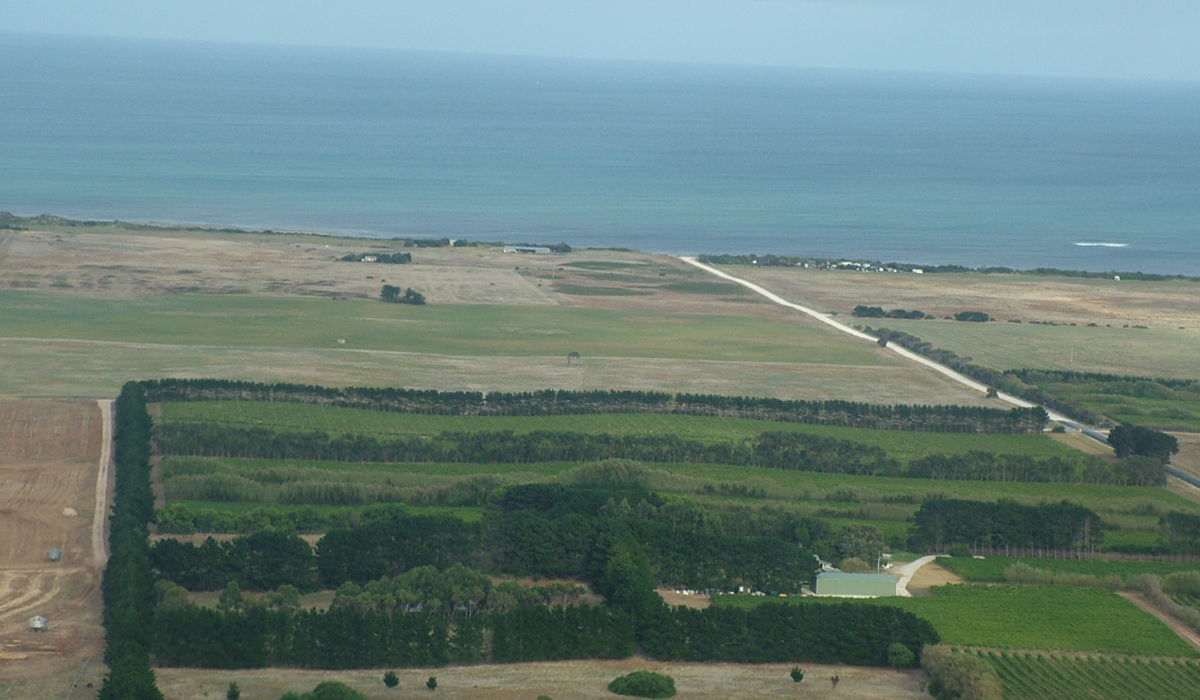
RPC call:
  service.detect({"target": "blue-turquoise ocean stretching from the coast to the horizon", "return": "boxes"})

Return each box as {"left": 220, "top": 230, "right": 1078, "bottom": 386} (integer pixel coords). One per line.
{"left": 0, "top": 34, "right": 1200, "bottom": 275}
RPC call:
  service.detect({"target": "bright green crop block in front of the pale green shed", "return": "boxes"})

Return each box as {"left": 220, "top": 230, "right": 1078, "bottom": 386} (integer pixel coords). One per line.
{"left": 714, "top": 584, "right": 1200, "bottom": 658}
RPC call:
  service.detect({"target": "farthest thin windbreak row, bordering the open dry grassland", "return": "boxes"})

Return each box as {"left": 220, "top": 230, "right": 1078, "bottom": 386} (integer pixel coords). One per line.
{"left": 142, "top": 379, "right": 1048, "bottom": 433}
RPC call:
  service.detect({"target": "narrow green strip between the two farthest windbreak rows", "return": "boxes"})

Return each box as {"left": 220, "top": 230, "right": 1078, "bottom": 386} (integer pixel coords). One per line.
{"left": 162, "top": 401, "right": 1079, "bottom": 462}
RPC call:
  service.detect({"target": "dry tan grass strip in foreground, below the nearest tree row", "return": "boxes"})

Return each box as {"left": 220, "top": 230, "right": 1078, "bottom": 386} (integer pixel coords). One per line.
{"left": 157, "top": 659, "right": 928, "bottom": 700}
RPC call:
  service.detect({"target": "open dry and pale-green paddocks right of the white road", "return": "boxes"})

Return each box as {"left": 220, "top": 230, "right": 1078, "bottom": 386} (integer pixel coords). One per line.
{"left": 722, "top": 265, "right": 1200, "bottom": 378}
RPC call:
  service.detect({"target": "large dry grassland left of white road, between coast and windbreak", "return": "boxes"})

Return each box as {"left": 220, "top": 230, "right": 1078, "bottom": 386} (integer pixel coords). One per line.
{"left": 0, "top": 227, "right": 984, "bottom": 405}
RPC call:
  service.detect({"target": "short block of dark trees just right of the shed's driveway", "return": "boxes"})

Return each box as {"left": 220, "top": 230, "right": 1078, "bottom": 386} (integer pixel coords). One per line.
{"left": 910, "top": 498, "right": 1104, "bottom": 551}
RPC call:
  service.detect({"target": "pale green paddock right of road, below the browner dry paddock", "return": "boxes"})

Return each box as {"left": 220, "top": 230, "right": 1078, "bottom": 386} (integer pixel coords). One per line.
{"left": 878, "top": 318, "right": 1198, "bottom": 378}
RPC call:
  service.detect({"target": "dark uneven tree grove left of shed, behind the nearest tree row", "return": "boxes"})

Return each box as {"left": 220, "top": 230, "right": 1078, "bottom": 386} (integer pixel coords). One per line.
{"left": 150, "top": 484, "right": 838, "bottom": 592}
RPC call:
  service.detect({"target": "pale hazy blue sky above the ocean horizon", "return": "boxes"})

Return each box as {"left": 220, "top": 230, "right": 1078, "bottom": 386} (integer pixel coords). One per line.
{"left": 7, "top": 0, "right": 1200, "bottom": 80}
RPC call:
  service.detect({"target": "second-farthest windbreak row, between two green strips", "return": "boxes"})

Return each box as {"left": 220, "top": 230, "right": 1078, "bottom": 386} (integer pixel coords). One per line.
{"left": 157, "top": 421, "right": 1147, "bottom": 486}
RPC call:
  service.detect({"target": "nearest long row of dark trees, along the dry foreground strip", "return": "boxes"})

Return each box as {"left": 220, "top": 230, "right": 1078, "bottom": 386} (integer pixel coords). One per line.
{"left": 154, "top": 603, "right": 938, "bottom": 669}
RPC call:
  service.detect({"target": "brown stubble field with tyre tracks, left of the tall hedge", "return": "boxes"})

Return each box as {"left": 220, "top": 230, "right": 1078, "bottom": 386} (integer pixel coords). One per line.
{"left": 0, "top": 400, "right": 103, "bottom": 699}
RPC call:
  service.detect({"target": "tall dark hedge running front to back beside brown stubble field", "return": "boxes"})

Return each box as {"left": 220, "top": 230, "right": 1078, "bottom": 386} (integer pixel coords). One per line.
{"left": 96, "top": 382, "right": 162, "bottom": 700}
